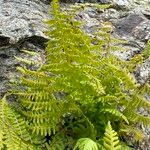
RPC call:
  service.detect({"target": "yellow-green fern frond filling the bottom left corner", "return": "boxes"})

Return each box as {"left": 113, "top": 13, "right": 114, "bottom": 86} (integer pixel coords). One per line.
{"left": 0, "top": 98, "right": 36, "bottom": 150}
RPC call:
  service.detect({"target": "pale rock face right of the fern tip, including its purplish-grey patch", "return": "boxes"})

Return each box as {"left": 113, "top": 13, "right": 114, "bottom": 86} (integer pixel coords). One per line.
{"left": 79, "top": 3, "right": 150, "bottom": 86}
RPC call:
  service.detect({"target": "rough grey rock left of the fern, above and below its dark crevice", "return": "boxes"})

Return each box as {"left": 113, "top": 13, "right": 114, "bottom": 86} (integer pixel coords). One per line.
{"left": 0, "top": 0, "right": 49, "bottom": 97}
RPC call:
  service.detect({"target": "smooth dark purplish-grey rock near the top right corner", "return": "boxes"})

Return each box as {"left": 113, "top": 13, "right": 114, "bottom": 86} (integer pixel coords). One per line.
{"left": 113, "top": 10, "right": 150, "bottom": 42}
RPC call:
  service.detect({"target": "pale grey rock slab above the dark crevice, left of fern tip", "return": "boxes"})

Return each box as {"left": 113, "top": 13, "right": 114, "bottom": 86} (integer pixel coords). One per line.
{"left": 0, "top": 0, "right": 49, "bottom": 46}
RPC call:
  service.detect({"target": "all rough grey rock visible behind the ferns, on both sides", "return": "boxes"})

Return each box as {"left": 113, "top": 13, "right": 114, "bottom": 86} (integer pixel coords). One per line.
{"left": 0, "top": 0, "right": 150, "bottom": 150}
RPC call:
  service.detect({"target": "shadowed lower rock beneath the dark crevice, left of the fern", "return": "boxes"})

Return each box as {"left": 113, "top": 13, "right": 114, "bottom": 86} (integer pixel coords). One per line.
{"left": 0, "top": 41, "right": 45, "bottom": 98}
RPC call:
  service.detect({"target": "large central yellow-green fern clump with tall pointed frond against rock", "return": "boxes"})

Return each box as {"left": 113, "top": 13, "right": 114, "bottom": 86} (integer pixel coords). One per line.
{"left": 18, "top": 0, "right": 149, "bottom": 146}
